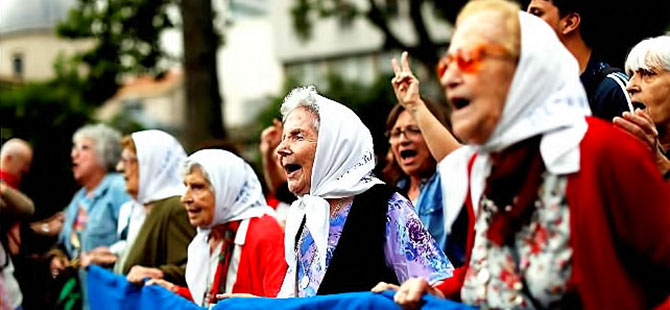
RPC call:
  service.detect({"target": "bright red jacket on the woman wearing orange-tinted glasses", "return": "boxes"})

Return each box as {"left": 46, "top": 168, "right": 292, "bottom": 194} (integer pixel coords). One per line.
{"left": 436, "top": 118, "right": 670, "bottom": 309}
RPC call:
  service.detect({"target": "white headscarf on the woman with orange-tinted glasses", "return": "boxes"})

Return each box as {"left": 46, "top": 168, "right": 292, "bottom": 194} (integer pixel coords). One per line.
{"left": 439, "top": 12, "right": 591, "bottom": 232}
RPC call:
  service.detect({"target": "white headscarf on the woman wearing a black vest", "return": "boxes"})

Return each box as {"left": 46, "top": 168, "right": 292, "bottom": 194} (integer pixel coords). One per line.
{"left": 278, "top": 87, "right": 383, "bottom": 297}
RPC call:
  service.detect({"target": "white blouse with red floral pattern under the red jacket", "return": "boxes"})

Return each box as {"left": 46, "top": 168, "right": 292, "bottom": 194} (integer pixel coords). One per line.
{"left": 461, "top": 173, "right": 572, "bottom": 309}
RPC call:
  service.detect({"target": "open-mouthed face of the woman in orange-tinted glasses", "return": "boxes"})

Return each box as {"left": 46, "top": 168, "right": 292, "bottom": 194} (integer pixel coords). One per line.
{"left": 440, "top": 11, "right": 516, "bottom": 144}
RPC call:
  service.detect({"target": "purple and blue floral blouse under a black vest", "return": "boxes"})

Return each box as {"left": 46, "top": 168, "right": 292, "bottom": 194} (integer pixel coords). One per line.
{"left": 297, "top": 193, "right": 454, "bottom": 297}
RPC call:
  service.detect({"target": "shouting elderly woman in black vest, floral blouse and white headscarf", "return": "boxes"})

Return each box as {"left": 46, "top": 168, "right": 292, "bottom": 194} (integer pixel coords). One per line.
{"left": 277, "top": 87, "right": 453, "bottom": 297}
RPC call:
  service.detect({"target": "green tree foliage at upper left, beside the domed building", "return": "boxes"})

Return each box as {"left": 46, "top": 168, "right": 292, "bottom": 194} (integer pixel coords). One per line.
{"left": 57, "top": 0, "right": 174, "bottom": 105}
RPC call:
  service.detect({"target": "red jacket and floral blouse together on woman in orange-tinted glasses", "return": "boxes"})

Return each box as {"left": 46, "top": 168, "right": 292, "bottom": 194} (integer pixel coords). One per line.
{"left": 438, "top": 119, "right": 670, "bottom": 309}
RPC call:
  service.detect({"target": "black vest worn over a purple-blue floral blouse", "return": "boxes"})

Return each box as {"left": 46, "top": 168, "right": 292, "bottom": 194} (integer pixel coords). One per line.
{"left": 316, "top": 184, "right": 399, "bottom": 295}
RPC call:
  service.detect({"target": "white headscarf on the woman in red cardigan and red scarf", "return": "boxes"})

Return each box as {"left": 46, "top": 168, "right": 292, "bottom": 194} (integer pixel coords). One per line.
{"left": 183, "top": 149, "right": 274, "bottom": 306}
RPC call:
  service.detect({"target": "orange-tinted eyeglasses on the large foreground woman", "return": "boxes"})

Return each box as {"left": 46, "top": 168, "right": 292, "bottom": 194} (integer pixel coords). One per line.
{"left": 436, "top": 44, "right": 510, "bottom": 78}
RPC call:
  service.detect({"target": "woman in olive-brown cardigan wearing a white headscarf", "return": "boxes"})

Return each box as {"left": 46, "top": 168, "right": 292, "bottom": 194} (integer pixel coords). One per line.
{"left": 112, "top": 130, "right": 195, "bottom": 283}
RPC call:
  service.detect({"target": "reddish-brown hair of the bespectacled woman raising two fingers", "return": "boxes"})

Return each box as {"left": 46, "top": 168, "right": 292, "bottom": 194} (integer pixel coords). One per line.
{"left": 382, "top": 97, "right": 451, "bottom": 185}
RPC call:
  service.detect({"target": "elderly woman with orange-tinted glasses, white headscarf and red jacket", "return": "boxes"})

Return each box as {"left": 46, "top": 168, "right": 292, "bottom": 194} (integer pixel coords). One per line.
{"left": 384, "top": 0, "right": 670, "bottom": 309}
